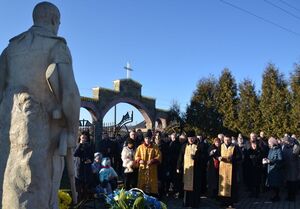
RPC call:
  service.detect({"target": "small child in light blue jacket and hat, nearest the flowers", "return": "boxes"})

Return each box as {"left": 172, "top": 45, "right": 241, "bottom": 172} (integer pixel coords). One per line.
{"left": 99, "top": 157, "right": 118, "bottom": 194}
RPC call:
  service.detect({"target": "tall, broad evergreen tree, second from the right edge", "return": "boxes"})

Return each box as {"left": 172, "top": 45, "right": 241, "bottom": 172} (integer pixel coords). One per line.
{"left": 260, "top": 64, "right": 290, "bottom": 137}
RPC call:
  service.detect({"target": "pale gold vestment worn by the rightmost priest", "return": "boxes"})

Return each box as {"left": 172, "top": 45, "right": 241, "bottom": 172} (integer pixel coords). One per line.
{"left": 219, "top": 144, "right": 234, "bottom": 197}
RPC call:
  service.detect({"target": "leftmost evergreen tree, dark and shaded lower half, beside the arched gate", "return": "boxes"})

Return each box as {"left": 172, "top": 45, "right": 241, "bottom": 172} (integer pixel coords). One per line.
{"left": 185, "top": 77, "right": 221, "bottom": 136}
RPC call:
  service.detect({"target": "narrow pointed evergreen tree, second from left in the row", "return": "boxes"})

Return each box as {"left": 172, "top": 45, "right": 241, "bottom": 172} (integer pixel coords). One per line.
{"left": 216, "top": 69, "right": 238, "bottom": 134}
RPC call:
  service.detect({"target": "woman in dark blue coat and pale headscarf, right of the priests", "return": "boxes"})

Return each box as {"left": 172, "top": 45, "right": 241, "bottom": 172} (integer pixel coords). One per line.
{"left": 263, "top": 137, "right": 283, "bottom": 202}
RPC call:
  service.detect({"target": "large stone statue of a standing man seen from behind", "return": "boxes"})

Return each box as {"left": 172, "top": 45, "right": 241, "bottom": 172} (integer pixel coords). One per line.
{"left": 0, "top": 2, "right": 80, "bottom": 209}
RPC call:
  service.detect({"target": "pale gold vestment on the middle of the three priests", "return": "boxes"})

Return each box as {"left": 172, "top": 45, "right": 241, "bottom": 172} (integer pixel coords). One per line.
{"left": 183, "top": 144, "right": 197, "bottom": 191}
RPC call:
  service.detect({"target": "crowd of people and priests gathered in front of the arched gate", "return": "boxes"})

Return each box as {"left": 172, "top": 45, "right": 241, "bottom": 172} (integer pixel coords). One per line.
{"left": 74, "top": 130, "right": 300, "bottom": 208}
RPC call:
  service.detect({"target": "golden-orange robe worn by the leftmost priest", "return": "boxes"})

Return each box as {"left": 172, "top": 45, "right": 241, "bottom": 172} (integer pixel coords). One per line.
{"left": 135, "top": 144, "right": 161, "bottom": 194}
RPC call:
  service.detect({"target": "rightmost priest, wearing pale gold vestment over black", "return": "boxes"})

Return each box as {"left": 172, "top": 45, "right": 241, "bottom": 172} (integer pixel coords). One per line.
{"left": 217, "top": 136, "right": 241, "bottom": 206}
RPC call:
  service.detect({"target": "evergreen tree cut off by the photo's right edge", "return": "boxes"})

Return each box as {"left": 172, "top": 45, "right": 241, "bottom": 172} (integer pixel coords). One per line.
{"left": 290, "top": 64, "right": 300, "bottom": 136}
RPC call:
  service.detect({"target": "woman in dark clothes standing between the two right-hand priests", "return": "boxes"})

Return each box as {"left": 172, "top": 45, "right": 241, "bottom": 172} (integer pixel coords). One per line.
{"left": 207, "top": 138, "right": 221, "bottom": 198}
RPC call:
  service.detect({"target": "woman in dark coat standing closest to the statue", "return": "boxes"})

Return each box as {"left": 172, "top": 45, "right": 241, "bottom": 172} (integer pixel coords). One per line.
{"left": 74, "top": 132, "right": 94, "bottom": 201}
